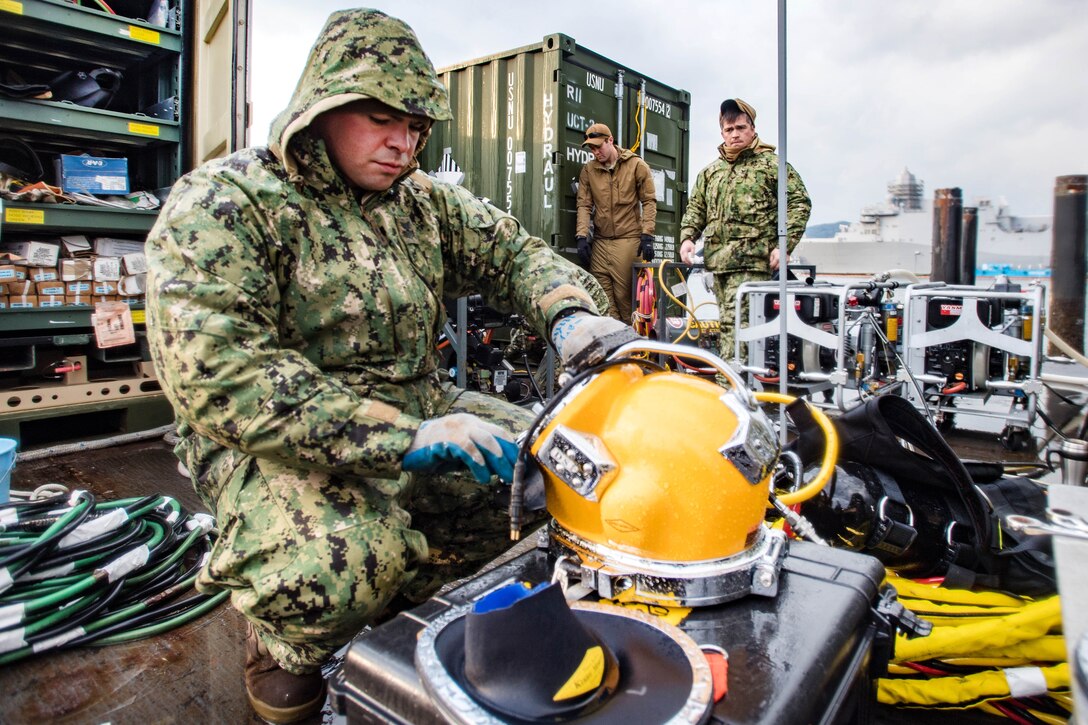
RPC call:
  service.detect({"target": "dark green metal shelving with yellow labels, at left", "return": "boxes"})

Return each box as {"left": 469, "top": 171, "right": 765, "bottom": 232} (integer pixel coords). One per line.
{"left": 0, "top": 0, "right": 194, "bottom": 444}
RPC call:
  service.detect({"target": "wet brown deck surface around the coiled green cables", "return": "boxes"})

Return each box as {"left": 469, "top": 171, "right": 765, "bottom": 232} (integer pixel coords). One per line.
{"left": 0, "top": 440, "right": 280, "bottom": 725}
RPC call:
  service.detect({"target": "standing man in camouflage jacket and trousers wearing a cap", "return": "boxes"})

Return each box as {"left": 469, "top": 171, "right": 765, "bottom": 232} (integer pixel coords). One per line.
{"left": 680, "top": 98, "right": 812, "bottom": 360}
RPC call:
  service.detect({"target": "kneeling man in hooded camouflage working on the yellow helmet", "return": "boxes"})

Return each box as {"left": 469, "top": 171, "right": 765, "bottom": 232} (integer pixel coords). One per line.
{"left": 147, "top": 10, "right": 623, "bottom": 722}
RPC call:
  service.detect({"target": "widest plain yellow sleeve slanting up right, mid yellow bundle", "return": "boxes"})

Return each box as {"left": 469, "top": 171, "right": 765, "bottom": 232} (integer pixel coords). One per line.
{"left": 895, "top": 595, "right": 1062, "bottom": 662}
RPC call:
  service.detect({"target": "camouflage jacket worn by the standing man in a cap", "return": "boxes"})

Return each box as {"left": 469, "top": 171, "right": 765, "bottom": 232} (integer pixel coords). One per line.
{"left": 680, "top": 145, "right": 812, "bottom": 277}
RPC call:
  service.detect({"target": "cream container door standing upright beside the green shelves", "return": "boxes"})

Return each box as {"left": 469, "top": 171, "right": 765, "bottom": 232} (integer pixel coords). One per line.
{"left": 189, "top": 0, "right": 251, "bottom": 167}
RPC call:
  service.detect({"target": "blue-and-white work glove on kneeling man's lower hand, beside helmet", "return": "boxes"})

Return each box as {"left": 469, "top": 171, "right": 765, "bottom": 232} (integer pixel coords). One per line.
{"left": 404, "top": 413, "right": 518, "bottom": 483}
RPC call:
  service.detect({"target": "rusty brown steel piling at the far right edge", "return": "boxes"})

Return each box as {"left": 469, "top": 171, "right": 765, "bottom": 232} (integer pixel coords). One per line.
{"left": 1048, "top": 174, "right": 1088, "bottom": 354}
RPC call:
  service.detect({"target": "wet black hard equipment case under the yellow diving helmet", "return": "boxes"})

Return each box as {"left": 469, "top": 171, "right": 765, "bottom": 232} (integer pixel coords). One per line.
{"left": 330, "top": 541, "right": 894, "bottom": 725}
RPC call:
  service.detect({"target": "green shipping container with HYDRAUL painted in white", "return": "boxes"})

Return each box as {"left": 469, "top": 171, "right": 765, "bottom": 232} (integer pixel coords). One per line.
{"left": 421, "top": 34, "right": 691, "bottom": 260}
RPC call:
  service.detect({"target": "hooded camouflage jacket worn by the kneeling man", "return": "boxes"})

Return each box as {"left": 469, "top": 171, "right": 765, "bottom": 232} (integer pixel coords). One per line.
{"left": 147, "top": 10, "right": 595, "bottom": 478}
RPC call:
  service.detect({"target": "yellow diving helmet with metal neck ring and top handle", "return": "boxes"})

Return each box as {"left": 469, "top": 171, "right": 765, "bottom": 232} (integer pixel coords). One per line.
{"left": 517, "top": 340, "right": 786, "bottom": 606}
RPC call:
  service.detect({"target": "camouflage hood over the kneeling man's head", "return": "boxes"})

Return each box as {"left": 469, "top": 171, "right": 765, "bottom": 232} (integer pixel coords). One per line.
{"left": 269, "top": 9, "right": 450, "bottom": 176}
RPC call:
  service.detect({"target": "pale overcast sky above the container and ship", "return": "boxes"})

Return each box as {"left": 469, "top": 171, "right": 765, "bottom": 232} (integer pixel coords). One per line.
{"left": 250, "top": 0, "right": 1088, "bottom": 223}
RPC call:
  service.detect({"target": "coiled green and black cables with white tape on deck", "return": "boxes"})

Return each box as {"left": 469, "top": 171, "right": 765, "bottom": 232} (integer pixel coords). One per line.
{"left": 0, "top": 492, "right": 221, "bottom": 665}
